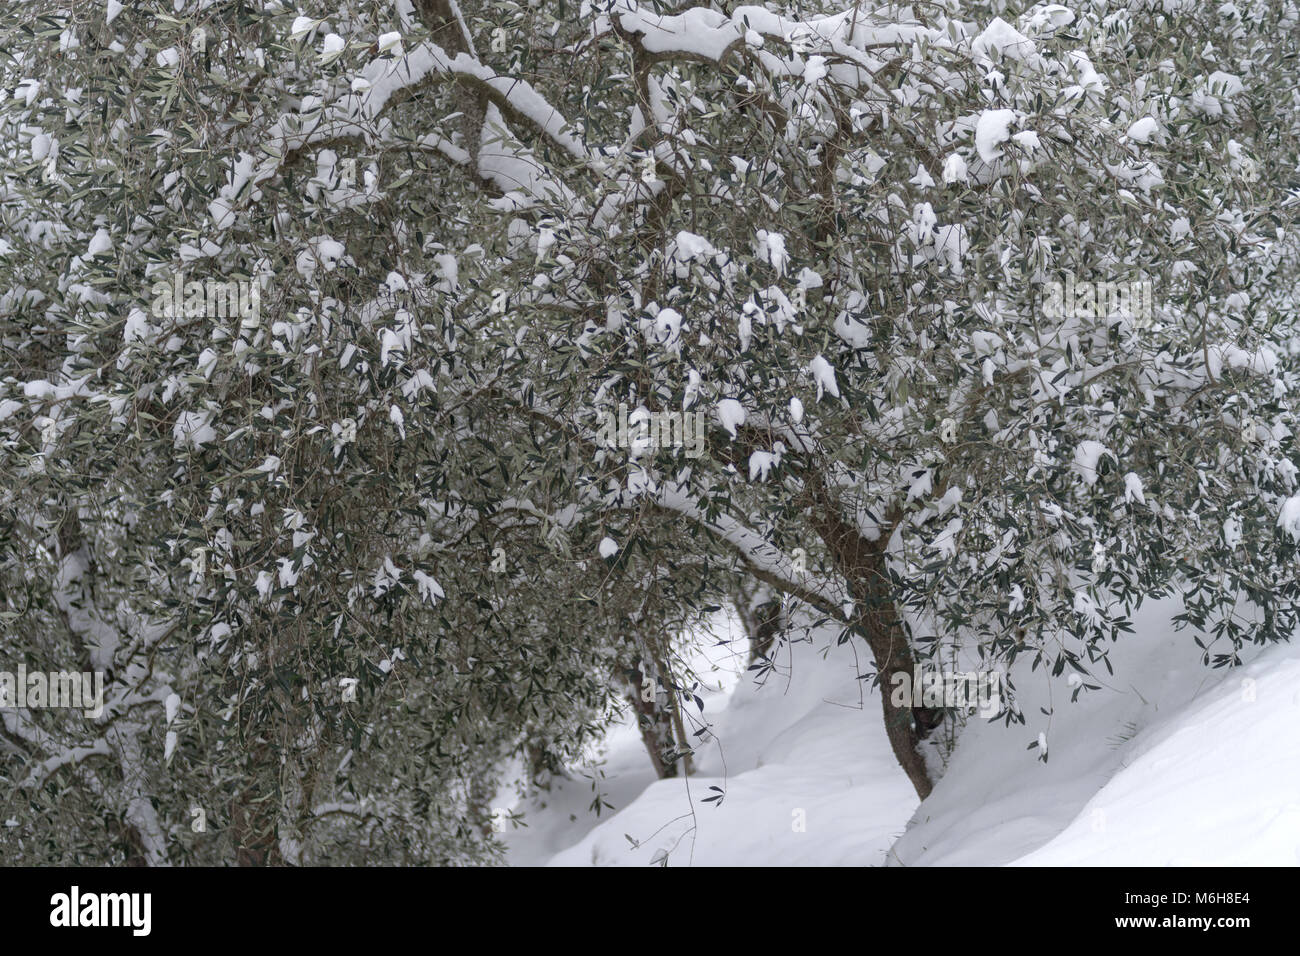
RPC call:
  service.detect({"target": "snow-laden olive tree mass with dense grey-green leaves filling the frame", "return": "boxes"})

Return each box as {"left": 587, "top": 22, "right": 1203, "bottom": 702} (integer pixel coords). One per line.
{"left": 0, "top": 0, "right": 1300, "bottom": 862}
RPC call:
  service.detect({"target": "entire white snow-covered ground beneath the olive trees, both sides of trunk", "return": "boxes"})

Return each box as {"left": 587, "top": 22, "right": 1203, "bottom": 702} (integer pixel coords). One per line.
{"left": 506, "top": 602, "right": 1300, "bottom": 866}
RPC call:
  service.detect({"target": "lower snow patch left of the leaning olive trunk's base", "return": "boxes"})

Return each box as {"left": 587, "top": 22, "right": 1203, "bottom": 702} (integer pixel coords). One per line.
{"left": 496, "top": 608, "right": 917, "bottom": 866}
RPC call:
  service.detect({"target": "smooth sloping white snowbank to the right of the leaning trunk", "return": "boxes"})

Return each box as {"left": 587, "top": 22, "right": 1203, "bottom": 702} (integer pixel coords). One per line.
{"left": 891, "top": 602, "right": 1300, "bottom": 865}
